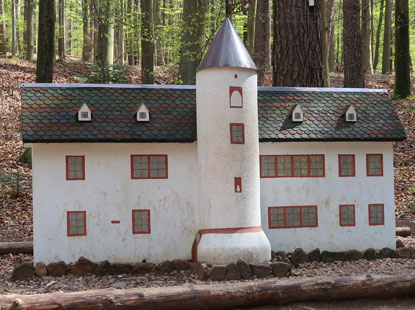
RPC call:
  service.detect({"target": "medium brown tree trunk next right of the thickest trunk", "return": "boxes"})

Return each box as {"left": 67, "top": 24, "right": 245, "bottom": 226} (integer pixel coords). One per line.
{"left": 343, "top": 0, "right": 365, "bottom": 87}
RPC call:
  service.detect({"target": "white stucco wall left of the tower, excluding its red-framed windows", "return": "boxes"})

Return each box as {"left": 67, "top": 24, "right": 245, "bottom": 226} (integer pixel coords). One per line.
{"left": 33, "top": 143, "right": 199, "bottom": 263}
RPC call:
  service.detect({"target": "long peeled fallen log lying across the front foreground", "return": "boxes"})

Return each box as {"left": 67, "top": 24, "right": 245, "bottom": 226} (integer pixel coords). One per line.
{"left": 0, "top": 274, "right": 415, "bottom": 310}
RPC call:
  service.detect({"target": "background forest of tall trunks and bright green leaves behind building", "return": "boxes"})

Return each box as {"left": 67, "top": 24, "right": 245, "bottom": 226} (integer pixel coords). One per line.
{"left": 0, "top": 0, "right": 415, "bottom": 97}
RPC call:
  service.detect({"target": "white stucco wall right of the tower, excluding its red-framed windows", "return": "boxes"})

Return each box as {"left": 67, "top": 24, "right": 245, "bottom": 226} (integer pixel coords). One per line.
{"left": 260, "top": 142, "right": 395, "bottom": 251}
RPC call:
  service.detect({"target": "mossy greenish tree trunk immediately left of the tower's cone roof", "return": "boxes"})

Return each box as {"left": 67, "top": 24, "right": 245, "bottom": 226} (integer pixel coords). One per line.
{"left": 179, "top": 0, "right": 208, "bottom": 84}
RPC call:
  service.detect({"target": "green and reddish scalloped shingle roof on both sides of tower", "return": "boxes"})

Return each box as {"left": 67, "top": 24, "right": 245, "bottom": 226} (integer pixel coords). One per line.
{"left": 21, "top": 84, "right": 406, "bottom": 143}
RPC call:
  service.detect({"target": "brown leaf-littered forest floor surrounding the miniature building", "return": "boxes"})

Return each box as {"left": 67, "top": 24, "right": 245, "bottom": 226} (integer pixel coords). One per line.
{"left": 0, "top": 60, "right": 415, "bottom": 310}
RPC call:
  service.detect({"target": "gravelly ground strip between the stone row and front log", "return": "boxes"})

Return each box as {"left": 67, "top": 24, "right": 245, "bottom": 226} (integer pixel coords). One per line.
{"left": 0, "top": 254, "right": 415, "bottom": 294}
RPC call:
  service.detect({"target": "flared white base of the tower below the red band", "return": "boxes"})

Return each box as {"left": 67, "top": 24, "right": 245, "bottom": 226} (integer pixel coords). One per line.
{"left": 197, "top": 231, "right": 271, "bottom": 264}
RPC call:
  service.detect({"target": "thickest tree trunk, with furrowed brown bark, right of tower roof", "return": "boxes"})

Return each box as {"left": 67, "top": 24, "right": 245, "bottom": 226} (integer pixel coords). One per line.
{"left": 273, "top": 0, "right": 324, "bottom": 87}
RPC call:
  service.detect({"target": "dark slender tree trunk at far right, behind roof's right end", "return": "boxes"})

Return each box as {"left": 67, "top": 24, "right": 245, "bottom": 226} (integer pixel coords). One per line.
{"left": 394, "top": 0, "right": 411, "bottom": 98}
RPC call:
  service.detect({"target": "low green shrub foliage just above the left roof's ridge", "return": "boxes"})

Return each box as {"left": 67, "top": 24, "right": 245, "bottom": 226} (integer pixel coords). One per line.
{"left": 76, "top": 64, "right": 130, "bottom": 84}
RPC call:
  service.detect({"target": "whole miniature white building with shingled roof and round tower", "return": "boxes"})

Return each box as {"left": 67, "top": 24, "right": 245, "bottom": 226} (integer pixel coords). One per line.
{"left": 22, "top": 20, "right": 406, "bottom": 263}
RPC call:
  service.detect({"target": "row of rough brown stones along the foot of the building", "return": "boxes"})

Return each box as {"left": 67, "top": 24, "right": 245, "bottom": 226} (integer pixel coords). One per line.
{"left": 12, "top": 246, "right": 415, "bottom": 281}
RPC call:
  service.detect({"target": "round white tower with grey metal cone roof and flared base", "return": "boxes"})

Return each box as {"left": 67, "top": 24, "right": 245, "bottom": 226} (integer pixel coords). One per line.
{"left": 196, "top": 19, "right": 271, "bottom": 264}
